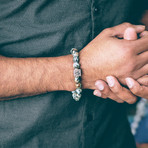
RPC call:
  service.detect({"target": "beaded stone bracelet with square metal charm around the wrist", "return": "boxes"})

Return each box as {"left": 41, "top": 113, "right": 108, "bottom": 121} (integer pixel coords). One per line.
{"left": 70, "top": 48, "right": 82, "bottom": 101}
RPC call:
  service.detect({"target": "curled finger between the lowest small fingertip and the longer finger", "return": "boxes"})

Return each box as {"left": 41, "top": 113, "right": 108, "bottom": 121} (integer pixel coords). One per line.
{"left": 95, "top": 80, "right": 124, "bottom": 103}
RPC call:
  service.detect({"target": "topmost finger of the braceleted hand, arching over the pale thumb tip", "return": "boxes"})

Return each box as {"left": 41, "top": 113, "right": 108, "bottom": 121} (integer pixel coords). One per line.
{"left": 111, "top": 23, "right": 145, "bottom": 37}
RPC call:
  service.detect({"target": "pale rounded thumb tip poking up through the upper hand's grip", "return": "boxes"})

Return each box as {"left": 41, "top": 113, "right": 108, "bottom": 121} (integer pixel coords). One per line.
{"left": 123, "top": 27, "right": 138, "bottom": 40}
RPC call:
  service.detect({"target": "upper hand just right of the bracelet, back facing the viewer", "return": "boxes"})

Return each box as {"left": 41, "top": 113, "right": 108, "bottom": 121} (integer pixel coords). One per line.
{"left": 80, "top": 23, "right": 148, "bottom": 89}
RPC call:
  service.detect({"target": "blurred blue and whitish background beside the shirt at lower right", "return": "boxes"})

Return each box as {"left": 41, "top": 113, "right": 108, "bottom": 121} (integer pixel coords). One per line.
{"left": 127, "top": 98, "right": 148, "bottom": 148}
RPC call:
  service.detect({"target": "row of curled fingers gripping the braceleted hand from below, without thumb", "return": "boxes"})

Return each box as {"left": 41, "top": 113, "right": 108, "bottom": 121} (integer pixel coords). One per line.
{"left": 94, "top": 76, "right": 148, "bottom": 104}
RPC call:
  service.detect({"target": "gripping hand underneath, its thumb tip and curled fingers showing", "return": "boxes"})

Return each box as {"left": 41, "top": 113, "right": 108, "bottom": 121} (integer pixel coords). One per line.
{"left": 94, "top": 28, "right": 148, "bottom": 103}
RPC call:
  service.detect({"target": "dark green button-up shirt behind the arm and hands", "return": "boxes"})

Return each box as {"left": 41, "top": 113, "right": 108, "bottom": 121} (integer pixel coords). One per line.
{"left": 0, "top": 0, "right": 144, "bottom": 148}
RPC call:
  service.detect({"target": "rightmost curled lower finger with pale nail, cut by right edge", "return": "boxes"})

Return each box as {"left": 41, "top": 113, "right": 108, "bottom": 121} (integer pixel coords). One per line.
{"left": 126, "top": 78, "right": 148, "bottom": 99}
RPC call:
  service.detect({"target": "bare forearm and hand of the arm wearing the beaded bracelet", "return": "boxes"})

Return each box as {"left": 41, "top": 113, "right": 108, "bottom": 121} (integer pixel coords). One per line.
{"left": 0, "top": 23, "right": 148, "bottom": 100}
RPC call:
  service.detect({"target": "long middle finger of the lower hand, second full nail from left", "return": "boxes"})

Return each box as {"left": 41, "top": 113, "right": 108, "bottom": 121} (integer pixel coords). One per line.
{"left": 106, "top": 76, "right": 137, "bottom": 104}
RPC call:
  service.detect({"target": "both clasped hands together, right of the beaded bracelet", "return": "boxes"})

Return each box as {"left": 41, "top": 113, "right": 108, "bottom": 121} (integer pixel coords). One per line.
{"left": 80, "top": 23, "right": 148, "bottom": 104}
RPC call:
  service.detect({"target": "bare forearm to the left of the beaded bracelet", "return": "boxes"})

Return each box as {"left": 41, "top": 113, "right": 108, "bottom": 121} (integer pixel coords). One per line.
{"left": 0, "top": 55, "right": 75, "bottom": 100}
